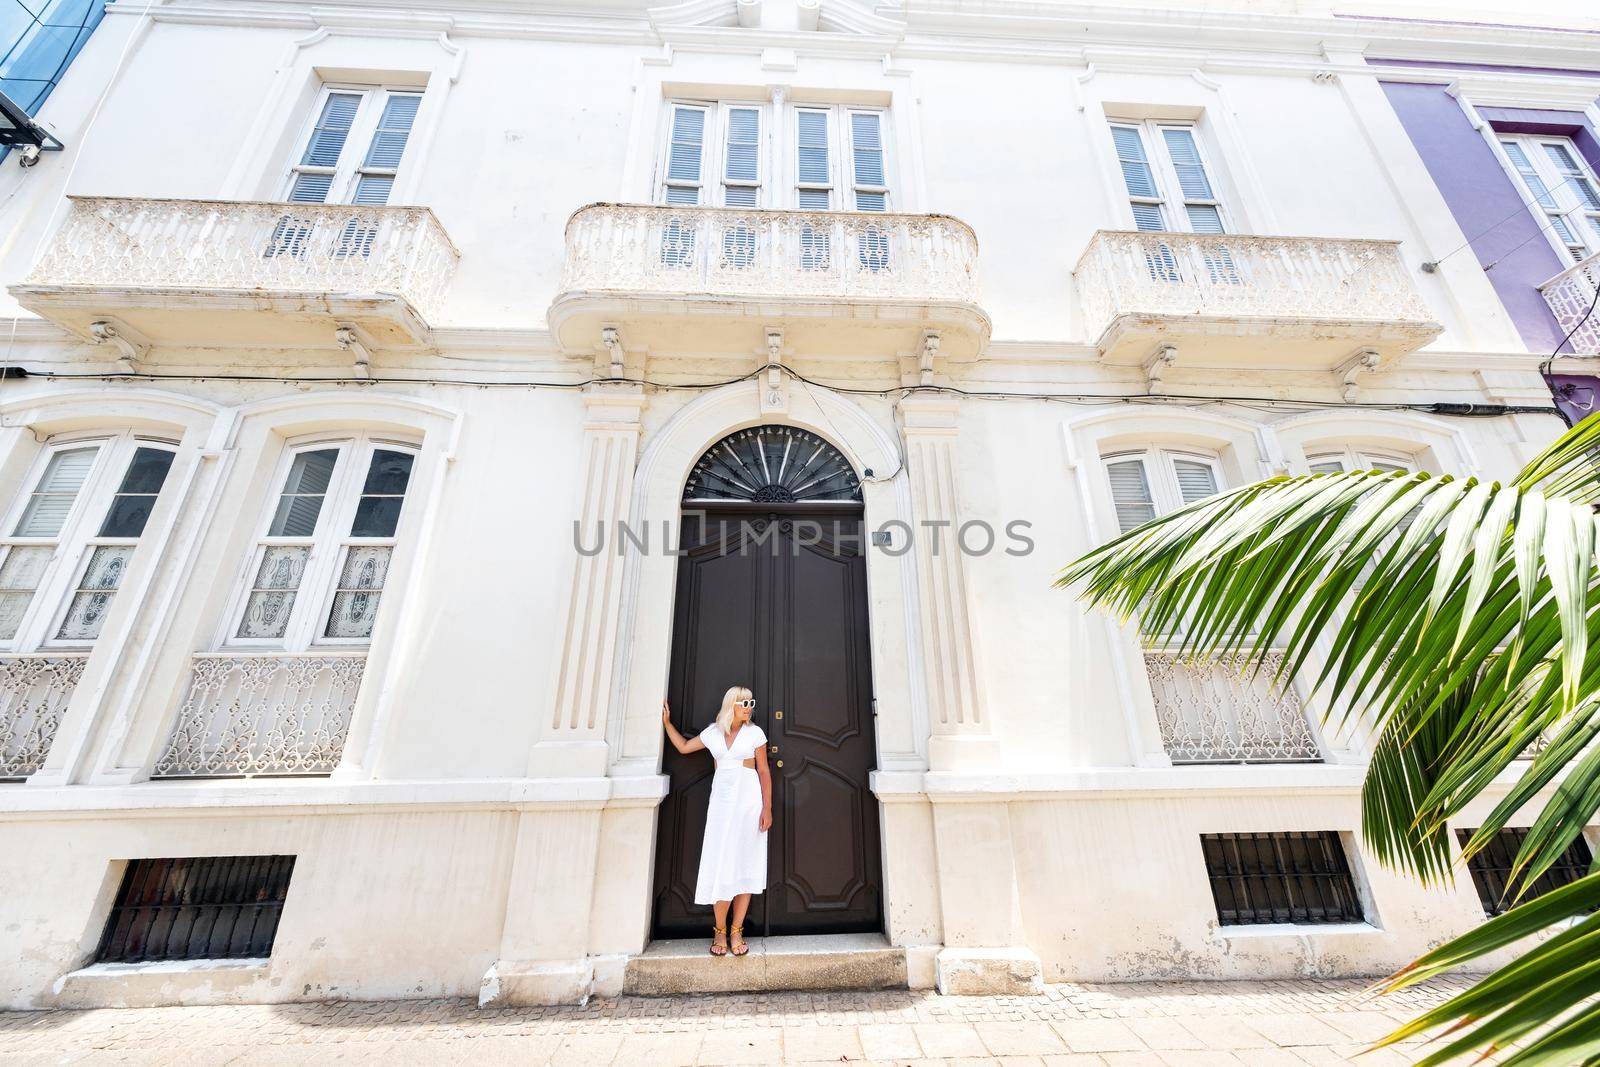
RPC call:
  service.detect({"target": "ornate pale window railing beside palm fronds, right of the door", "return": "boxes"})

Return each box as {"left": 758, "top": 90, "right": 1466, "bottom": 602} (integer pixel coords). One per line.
{"left": 1144, "top": 653, "right": 1322, "bottom": 763}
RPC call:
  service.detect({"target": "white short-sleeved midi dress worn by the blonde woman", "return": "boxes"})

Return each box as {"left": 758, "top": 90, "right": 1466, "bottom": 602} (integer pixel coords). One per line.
{"left": 694, "top": 723, "right": 766, "bottom": 904}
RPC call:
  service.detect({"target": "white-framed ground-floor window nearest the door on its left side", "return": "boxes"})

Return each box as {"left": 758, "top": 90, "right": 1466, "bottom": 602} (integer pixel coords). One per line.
{"left": 218, "top": 434, "right": 419, "bottom": 651}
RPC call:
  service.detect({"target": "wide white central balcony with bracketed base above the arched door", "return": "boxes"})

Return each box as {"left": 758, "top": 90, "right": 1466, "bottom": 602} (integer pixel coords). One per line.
{"left": 549, "top": 203, "right": 989, "bottom": 360}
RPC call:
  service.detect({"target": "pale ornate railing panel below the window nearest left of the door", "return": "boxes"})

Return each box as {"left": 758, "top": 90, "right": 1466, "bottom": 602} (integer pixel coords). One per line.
{"left": 152, "top": 653, "right": 366, "bottom": 777}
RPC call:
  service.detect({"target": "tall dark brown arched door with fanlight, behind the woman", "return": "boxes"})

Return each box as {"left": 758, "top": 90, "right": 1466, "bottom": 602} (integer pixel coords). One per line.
{"left": 653, "top": 426, "right": 883, "bottom": 937}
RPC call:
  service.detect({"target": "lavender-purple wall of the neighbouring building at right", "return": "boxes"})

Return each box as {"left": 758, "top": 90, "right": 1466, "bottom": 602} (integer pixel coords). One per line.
{"left": 1382, "top": 82, "right": 1574, "bottom": 352}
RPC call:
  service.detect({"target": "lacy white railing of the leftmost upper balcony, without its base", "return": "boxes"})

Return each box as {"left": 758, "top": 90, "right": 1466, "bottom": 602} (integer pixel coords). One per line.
{"left": 24, "top": 197, "right": 461, "bottom": 320}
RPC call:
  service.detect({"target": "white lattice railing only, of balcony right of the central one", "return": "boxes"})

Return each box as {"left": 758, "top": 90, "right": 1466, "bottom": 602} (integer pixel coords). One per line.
{"left": 1074, "top": 230, "right": 1432, "bottom": 336}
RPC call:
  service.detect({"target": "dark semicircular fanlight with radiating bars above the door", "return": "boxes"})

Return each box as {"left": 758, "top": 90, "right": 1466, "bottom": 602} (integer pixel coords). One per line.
{"left": 683, "top": 426, "right": 861, "bottom": 504}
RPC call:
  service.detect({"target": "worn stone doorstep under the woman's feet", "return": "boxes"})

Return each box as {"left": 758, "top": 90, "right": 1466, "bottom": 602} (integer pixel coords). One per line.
{"left": 622, "top": 934, "right": 906, "bottom": 997}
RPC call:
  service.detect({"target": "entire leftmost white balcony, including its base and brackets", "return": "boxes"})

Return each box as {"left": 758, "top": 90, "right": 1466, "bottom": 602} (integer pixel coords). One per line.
{"left": 11, "top": 197, "right": 459, "bottom": 350}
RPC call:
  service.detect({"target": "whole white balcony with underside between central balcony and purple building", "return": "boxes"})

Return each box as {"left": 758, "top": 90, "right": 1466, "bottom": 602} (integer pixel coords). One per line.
{"left": 1074, "top": 230, "right": 1440, "bottom": 370}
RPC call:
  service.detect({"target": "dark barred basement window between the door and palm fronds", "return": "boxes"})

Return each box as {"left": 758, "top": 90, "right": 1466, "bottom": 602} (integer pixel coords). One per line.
{"left": 1200, "top": 830, "right": 1366, "bottom": 926}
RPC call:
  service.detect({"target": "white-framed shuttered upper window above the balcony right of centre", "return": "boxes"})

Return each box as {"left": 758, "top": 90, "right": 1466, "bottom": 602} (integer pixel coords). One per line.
{"left": 1109, "top": 118, "right": 1234, "bottom": 234}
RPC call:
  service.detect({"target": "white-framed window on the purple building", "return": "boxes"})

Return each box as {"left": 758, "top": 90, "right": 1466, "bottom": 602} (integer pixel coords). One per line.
{"left": 1493, "top": 133, "right": 1600, "bottom": 264}
